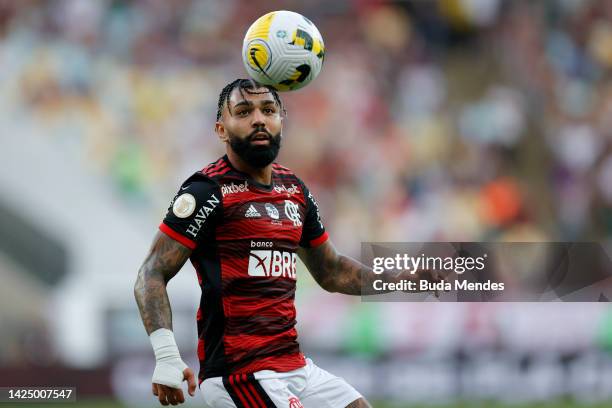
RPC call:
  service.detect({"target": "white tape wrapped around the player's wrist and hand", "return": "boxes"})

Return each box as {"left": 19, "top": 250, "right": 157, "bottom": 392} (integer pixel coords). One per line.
{"left": 149, "top": 329, "right": 187, "bottom": 388}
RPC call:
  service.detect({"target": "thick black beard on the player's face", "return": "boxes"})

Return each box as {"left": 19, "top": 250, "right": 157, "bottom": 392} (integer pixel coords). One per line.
{"left": 228, "top": 129, "right": 281, "bottom": 169}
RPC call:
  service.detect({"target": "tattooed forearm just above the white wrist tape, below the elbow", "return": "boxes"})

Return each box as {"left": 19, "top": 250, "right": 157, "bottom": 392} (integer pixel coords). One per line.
{"left": 134, "top": 267, "right": 172, "bottom": 334}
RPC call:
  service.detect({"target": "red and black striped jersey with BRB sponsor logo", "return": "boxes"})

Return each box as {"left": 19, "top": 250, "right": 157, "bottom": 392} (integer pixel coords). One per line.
{"left": 160, "top": 156, "right": 327, "bottom": 381}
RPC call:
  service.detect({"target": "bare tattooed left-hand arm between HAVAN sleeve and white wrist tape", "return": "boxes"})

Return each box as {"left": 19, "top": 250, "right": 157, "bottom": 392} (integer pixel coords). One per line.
{"left": 134, "top": 232, "right": 192, "bottom": 334}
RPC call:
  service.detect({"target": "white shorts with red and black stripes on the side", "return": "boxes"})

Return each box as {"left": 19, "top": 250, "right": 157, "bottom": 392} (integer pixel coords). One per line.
{"left": 200, "top": 358, "right": 362, "bottom": 408}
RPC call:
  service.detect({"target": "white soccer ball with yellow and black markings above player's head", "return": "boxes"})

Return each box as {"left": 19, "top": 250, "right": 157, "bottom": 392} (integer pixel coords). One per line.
{"left": 242, "top": 10, "right": 325, "bottom": 91}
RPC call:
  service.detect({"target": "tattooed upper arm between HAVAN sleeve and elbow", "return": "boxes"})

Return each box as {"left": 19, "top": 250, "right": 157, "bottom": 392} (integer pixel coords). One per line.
{"left": 140, "top": 232, "right": 192, "bottom": 282}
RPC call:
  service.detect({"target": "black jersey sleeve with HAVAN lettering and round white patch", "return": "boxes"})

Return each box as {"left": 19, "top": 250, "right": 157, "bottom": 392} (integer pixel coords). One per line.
{"left": 159, "top": 173, "right": 221, "bottom": 249}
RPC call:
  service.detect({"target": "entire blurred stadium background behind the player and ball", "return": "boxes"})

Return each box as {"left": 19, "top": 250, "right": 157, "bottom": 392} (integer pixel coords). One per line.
{"left": 0, "top": 0, "right": 612, "bottom": 408}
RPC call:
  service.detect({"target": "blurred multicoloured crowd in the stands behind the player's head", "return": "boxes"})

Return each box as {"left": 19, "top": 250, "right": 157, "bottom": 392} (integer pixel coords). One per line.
{"left": 0, "top": 0, "right": 612, "bottom": 255}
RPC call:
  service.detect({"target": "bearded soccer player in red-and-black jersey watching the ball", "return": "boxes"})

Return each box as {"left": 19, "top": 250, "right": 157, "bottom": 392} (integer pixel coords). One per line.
{"left": 134, "top": 79, "right": 426, "bottom": 408}
